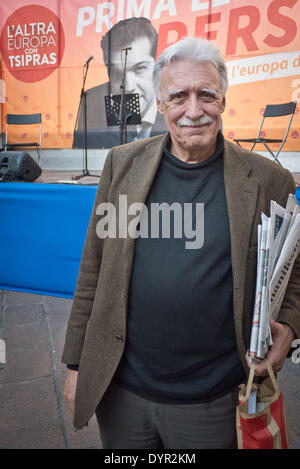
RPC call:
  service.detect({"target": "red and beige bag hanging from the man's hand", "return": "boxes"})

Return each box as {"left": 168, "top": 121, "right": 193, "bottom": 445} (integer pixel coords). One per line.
{"left": 236, "top": 360, "right": 288, "bottom": 449}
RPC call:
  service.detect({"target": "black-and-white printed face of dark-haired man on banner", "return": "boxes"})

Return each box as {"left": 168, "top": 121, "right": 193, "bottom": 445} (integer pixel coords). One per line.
{"left": 110, "top": 37, "right": 155, "bottom": 117}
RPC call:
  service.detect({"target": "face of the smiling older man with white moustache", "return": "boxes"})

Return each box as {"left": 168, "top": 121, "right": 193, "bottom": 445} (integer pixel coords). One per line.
{"left": 157, "top": 60, "right": 225, "bottom": 159}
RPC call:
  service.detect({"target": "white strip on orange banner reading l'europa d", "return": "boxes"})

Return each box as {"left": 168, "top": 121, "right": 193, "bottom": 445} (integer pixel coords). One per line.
{"left": 226, "top": 51, "right": 300, "bottom": 86}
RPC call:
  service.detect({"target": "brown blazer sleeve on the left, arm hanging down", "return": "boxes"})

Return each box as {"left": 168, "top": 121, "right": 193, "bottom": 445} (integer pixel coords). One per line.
{"left": 61, "top": 150, "right": 113, "bottom": 365}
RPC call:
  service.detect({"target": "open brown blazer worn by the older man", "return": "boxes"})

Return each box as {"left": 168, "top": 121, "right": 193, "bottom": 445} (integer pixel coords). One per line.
{"left": 62, "top": 135, "right": 300, "bottom": 429}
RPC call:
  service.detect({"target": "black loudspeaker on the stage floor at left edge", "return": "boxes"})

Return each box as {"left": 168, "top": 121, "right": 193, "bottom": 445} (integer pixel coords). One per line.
{"left": 0, "top": 151, "right": 42, "bottom": 182}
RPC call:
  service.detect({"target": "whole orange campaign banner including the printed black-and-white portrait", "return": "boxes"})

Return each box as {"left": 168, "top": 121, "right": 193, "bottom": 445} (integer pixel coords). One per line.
{"left": 0, "top": 0, "right": 300, "bottom": 152}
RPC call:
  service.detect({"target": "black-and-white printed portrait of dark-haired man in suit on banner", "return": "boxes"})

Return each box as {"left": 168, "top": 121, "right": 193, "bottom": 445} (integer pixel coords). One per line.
{"left": 73, "top": 17, "right": 166, "bottom": 148}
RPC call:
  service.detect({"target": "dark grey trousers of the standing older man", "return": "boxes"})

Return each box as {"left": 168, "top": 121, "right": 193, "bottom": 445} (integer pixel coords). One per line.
{"left": 96, "top": 384, "right": 238, "bottom": 449}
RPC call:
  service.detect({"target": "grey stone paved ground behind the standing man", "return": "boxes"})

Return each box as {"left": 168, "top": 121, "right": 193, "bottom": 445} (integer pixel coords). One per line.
{"left": 0, "top": 290, "right": 300, "bottom": 449}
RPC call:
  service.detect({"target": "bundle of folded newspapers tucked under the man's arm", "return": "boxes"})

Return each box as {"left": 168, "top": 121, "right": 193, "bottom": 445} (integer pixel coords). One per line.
{"left": 249, "top": 194, "right": 300, "bottom": 361}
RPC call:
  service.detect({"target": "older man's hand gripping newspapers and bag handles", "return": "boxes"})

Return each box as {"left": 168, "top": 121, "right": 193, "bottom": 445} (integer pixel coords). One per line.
{"left": 246, "top": 319, "right": 295, "bottom": 376}
